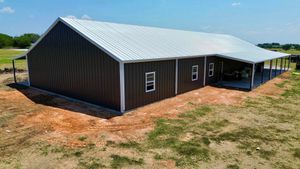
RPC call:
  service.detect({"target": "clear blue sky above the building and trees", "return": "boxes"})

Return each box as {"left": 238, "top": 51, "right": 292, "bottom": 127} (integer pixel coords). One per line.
{"left": 0, "top": 0, "right": 300, "bottom": 43}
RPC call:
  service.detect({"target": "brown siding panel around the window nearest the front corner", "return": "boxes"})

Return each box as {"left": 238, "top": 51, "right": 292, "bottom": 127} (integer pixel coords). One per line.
{"left": 124, "top": 60, "right": 176, "bottom": 110}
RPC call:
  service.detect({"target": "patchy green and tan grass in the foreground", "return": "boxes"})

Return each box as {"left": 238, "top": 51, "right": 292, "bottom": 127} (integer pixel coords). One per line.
{"left": 0, "top": 69, "right": 300, "bottom": 166}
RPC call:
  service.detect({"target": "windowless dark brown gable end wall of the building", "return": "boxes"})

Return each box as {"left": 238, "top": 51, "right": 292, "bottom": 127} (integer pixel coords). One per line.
{"left": 28, "top": 22, "right": 120, "bottom": 111}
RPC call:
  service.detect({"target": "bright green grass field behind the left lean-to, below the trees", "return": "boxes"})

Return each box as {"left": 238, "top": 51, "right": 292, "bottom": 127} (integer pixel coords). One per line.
{"left": 0, "top": 49, "right": 27, "bottom": 70}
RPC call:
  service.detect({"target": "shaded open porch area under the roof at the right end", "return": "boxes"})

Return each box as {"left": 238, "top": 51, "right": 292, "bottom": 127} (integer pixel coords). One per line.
{"left": 216, "top": 56, "right": 290, "bottom": 90}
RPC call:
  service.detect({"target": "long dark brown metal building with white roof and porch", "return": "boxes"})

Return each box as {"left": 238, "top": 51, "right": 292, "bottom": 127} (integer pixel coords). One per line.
{"left": 14, "top": 18, "right": 290, "bottom": 112}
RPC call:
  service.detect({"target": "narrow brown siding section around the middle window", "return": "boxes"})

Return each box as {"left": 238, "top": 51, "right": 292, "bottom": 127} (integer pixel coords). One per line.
{"left": 178, "top": 57, "right": 204, "bottom": 94}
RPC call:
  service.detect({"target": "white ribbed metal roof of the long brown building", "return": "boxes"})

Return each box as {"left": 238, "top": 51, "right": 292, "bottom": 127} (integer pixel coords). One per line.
{"left": 39, "top": 18, "right": 288, "bottom": 63}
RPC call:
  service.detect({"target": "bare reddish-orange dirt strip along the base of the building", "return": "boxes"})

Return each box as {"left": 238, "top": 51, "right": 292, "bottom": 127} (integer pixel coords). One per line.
{"left": 0, "top": 73, "right": 284, "bottom": 146}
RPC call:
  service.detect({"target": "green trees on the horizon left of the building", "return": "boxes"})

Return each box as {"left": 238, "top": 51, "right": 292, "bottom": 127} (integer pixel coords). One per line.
{"left": 0, "top": 33, "right": 40, "bottom": 48}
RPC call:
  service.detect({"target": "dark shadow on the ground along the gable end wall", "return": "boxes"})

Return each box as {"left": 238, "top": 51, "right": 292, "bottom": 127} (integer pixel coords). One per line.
{"left": 7, "top": 83, "right": 122, "bottom": 119}
